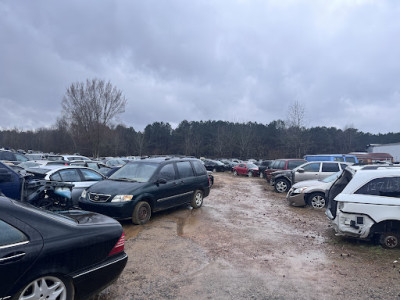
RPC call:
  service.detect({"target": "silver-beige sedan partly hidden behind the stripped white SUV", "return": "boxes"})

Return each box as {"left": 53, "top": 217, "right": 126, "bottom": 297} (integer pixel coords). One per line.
{"left": 286, "top": 171, "right": 343, "bottom": 209}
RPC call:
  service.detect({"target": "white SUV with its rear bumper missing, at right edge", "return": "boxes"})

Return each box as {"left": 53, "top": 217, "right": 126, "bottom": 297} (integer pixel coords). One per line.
{"left": 326, "top": 165, "right": 400, "bottom": 248}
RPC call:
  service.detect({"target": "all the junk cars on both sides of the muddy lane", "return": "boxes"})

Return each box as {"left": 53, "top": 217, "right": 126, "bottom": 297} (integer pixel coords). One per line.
{"left": 0, "top": 149, "right": 400, "bottom": 300}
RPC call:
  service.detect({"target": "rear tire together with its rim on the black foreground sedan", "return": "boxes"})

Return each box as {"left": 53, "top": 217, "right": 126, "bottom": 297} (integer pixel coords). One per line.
{"left": 12, "top": 275, "right": 75, "bottom": 300}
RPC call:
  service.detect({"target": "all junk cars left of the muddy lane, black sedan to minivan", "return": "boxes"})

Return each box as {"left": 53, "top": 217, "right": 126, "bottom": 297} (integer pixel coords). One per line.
{"left": 0, "top": 149, "right": 213, "bottom": 300}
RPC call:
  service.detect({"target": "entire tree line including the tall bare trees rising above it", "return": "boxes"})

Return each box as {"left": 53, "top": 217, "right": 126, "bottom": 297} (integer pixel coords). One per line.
{"left": 0, "top": 79, "right": 400, "bottom": 159}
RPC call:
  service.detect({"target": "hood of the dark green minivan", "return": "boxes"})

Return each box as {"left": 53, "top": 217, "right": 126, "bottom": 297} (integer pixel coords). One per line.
{"left": 88, "top": 179, "right": 146, "bottom": 196}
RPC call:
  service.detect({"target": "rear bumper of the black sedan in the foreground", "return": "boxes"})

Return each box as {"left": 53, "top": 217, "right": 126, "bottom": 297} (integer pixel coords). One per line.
{"left": 71, "top": 253, "right": 128, "bottom": 299}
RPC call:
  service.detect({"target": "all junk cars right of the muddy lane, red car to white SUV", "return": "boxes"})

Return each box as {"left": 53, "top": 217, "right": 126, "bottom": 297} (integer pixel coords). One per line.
{"left": 208, "top": 153, "right": 400, "bottom": 249}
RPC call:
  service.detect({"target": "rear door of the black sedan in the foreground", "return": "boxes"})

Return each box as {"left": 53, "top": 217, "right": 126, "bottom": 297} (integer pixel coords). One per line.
{"left": 0, "top": 212, "right": 43, "bottom": 299}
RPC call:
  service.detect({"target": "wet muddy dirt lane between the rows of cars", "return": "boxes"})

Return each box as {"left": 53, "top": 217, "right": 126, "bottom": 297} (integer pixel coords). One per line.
{"left": 95, "top": 173, "right": 400, "bottom": 300}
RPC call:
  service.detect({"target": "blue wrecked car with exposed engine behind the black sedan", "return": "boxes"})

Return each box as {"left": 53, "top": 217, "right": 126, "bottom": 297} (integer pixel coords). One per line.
{"left": 0, "top": 162, "right": 74, "bottom": 210}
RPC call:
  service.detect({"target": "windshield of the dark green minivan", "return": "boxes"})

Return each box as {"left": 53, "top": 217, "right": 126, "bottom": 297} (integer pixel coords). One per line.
{"left": 109, "top": 162, "right": 159, "bottom": 182}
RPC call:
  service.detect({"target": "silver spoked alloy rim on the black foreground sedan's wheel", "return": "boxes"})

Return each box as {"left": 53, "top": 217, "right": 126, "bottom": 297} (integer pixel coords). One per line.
{"left": 19, "top": 276, "right": 67, "bottom": 300}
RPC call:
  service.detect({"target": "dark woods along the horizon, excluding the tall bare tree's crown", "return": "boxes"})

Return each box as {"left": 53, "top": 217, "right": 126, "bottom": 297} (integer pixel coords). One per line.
{"left": 0, "top": 120, "right": 400, "bottom": 159}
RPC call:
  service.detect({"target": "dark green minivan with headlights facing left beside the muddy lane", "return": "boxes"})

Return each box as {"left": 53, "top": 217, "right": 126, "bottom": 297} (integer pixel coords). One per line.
{"left": 79, "top": 157, "right": 210, "bottom": 224}
